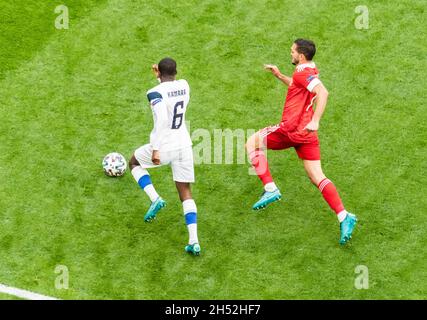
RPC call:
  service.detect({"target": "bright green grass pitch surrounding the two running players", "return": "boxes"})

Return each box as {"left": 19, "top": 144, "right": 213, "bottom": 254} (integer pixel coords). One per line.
{"left": 0, "top": 0, "right": 427, "bottom": 299}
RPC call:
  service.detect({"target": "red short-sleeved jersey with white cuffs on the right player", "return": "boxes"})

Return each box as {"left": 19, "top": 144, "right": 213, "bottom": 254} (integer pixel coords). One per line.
{"left": 280, "top": 62, "right": 320, "bottom": 143}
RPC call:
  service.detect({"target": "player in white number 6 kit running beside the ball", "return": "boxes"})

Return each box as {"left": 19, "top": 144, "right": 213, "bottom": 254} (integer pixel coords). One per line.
{"left": 129, "top": 58, "right": 200, "bottom": 255}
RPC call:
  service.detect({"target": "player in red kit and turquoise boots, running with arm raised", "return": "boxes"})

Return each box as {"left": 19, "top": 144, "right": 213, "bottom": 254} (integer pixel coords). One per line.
{"left": 246, "top": 39, "right": 357, "bottom": 244}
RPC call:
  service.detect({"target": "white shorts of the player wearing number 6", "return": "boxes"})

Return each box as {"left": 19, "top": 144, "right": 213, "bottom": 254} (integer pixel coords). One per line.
{"left": 135, "top": 144, "right": 194, "bottom": 182}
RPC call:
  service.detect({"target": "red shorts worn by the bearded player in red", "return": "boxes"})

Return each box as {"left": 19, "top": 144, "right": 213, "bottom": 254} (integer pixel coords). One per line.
{"left": 259, "top": 125, "right": 320, "bottom": 160}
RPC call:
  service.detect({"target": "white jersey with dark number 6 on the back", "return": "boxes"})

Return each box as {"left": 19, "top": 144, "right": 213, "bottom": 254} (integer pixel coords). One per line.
{"left": 147, "top": 79, "right": 192, "bottom": 151}
